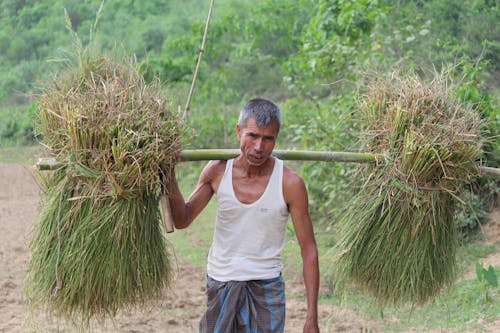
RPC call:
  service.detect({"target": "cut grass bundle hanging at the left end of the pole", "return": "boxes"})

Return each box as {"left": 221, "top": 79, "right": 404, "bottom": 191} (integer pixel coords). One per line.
{"left": 27, "top": 55, "right": 183, "bottom": 322}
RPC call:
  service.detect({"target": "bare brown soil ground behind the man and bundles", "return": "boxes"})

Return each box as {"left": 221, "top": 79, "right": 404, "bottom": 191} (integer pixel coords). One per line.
{"left": 0, "top": 163, "right": 500, "bottom": 333}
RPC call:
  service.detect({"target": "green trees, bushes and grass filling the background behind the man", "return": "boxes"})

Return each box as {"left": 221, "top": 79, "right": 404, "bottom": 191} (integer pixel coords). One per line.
{"left": 0, "top": 0, "right": 500, "bottom": 331}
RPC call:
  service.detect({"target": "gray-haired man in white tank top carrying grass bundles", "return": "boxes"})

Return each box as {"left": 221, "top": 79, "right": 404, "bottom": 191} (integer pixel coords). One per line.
{"left": 169, "top": 98, "right": 319, "bottom": 333}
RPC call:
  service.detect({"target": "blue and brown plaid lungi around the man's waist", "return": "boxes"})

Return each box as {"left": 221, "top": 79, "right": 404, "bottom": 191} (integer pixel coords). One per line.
{"left": 200, "top": 275, "right": 285, "bottom": 333}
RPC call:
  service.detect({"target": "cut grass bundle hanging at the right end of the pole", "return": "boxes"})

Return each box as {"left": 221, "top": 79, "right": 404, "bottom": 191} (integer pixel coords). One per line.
{"left": 332, "top": 74, "right": 481, "bottom": 305}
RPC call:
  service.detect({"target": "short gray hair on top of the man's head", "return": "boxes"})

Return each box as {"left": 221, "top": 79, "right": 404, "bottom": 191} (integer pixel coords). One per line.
{"left": 238, "top": 98, "right": 282, "bottom": 128}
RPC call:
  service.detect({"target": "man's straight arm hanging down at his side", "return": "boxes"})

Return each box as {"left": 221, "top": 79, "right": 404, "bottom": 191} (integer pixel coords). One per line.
{"left": 283, "top": 168, "right": 319, "bottom": 333}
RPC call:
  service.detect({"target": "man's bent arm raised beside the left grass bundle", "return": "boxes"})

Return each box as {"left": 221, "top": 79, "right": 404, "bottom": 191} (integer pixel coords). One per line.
{"left": 167, "top": 161, "right": 216, "bottom": 229}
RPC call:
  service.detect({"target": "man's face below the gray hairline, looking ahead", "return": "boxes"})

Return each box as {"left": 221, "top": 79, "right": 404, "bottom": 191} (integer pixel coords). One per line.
{"left": 236, "top": 118, "right": 279, "bottom": 166}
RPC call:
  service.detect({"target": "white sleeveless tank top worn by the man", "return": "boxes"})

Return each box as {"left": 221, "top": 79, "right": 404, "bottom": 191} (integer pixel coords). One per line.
{"left": 207, "top": 158, "right": 288, "bottom": 282}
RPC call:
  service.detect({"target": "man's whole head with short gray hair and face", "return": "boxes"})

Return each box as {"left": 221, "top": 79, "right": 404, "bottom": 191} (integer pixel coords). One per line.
{"left": 236, "top": 98, "right": 281, "bottom": 166}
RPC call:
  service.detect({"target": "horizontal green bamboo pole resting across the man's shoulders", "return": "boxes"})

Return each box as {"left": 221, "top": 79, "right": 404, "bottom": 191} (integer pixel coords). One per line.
{"left": 36, "top": 149, "right": 500, "bottom": 179}
